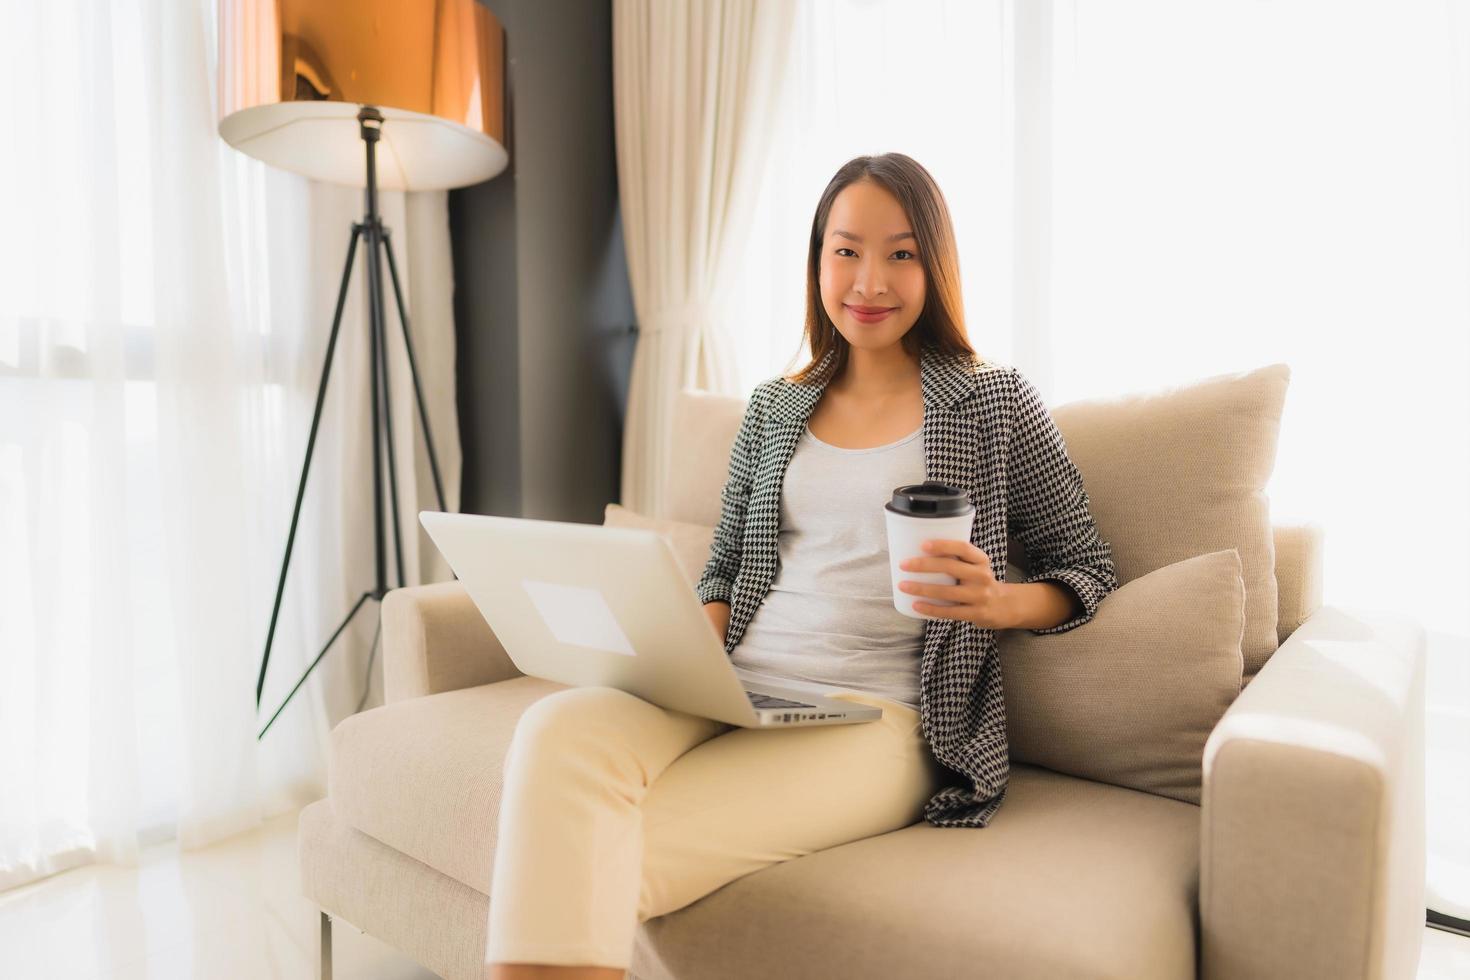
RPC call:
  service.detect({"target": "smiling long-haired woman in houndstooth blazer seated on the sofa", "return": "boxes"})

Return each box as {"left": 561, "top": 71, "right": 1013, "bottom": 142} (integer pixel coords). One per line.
{"left": 487, "top": 153, "right": 1117, "bottom": 980}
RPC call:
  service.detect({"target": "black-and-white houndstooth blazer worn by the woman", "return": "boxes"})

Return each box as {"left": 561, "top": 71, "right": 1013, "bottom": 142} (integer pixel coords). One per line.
{"left": 697, "top": 347, "right": 1117, "bottom": 827}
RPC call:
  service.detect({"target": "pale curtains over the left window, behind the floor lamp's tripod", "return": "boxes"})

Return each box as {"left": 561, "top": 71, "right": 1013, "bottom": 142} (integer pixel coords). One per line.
{"left": 0, "top": 0, "right": 460, "bottom": 887}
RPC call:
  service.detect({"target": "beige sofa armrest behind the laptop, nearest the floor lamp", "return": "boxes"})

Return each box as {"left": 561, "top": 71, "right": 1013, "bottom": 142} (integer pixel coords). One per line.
{"left": 382, "top": 580, "right": 520, "bottom": 704}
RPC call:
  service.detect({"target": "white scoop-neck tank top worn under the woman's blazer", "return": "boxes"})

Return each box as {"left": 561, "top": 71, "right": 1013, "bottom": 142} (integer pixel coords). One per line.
{"left": 731, "top": 426, "right": 926, "bottom": 708}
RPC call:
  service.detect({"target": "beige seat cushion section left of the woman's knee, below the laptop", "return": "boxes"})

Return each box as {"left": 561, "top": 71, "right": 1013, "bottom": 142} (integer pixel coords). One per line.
{"left": 328, "top": 676, "right": 566, "bottom": 895}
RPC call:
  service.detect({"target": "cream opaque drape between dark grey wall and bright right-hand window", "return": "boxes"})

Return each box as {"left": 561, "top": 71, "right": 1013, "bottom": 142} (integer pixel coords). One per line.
{"left": 613, "top": 0, "right": 794, "bottom": 516}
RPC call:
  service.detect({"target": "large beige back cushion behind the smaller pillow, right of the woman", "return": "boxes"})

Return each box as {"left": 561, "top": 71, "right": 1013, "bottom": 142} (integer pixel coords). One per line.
{"left": 1040, "top": 364, "right": 1291, "bottom": 683}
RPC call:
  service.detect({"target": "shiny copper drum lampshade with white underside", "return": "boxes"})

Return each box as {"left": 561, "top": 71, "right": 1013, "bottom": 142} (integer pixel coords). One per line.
{"left": 219, "top": 0, "right": 510, "bottom": 191}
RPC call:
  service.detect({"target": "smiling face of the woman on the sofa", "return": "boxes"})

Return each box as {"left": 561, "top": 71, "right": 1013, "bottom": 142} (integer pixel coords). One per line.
{"left": 819, "top": 181, "right": 925, "bottom": 357}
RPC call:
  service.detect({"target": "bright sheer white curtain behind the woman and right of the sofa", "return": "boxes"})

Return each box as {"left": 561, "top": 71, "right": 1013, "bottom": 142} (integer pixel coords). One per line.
{"left": 728, "top": 0, "right": 1470, "bottom": 917}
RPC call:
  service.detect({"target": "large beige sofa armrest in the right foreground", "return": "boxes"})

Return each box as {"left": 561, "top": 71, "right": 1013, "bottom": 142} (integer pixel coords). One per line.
{"left": 1200, "top": 605, "right": 1426, "bottom": 980}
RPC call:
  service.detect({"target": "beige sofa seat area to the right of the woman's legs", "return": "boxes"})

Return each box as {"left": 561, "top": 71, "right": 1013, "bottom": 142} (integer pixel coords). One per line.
{"left": 631, "top": 765, "right": 1200, "bottom": 980}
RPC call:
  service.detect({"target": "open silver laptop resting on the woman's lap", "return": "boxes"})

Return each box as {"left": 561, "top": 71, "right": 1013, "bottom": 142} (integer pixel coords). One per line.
{"left": 419, "top": 511, "right": 883, "bottom": 729}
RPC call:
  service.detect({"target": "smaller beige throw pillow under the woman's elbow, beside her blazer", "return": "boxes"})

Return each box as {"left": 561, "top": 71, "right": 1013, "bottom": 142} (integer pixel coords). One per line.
{"left": 997, "top": 548, "right": 1245, "bottom": 804}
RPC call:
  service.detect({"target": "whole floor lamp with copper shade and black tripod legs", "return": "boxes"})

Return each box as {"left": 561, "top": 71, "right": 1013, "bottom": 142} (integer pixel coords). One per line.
{"left": 219, "top": 0, "right": 510, "bottom": 739}
